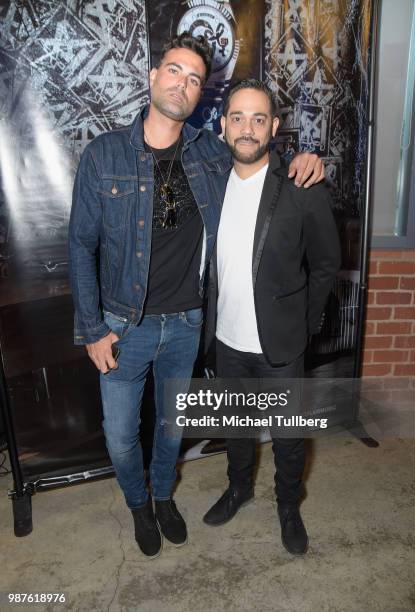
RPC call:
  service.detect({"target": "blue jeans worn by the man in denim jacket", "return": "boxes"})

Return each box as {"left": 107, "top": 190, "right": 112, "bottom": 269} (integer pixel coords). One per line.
{"left": 100, "top": 308, "right": 202, "bottom": 510}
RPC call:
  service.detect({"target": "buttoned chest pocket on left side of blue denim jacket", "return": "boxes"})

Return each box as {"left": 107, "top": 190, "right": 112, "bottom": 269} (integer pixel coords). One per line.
{"left": 98, "top": 179, "right": 134, "bottom": 229}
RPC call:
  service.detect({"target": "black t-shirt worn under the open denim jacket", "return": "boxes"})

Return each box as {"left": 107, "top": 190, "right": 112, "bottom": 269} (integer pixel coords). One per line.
{"left": 144, "top": 140, "right": 203, "bottom": 315}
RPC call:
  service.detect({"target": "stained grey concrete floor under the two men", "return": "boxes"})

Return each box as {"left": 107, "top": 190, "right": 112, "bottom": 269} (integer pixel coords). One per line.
{"left": 0, "top": 437, "right": 415, "bottom": 612}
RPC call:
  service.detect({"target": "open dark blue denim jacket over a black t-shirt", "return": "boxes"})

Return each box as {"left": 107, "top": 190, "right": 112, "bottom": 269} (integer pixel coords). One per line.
{"left": 69, "top": 107, "right": 232, "bottom": 344}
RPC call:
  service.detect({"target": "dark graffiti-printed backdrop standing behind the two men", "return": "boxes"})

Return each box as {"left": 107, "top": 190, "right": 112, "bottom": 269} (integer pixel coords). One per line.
{"left": 0, "top": 0, "right": 371, "bottom": 494}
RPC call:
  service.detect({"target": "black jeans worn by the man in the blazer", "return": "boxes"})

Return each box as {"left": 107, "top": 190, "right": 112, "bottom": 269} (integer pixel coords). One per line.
{"left": 216, "top": 340, "right": 305, "bottom": 504}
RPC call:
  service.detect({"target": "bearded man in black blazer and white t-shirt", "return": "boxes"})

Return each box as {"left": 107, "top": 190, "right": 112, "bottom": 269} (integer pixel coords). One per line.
{"left": 203, "top": 79, "right": 340, "bottom": 554}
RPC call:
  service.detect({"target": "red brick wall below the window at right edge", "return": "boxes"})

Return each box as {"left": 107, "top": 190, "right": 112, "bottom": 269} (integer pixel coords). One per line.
{"left": 362, "top": 250, "right": 415, "bottom": 376}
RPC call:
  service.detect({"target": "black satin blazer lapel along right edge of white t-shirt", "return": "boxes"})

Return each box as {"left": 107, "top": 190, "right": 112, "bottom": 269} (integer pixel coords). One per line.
{"left": 252, "top": 152, "right": 283, "bottom": 287}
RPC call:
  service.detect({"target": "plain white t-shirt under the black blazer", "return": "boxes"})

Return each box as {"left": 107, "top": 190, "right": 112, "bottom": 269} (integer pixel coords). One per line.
{"left": 216, "top": 164, "right": 268, "bottom": 353}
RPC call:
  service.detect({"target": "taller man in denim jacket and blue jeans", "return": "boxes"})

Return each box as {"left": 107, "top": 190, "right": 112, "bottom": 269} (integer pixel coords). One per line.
{"left": 69, "top": 33, "right": 324, "bottom": 557}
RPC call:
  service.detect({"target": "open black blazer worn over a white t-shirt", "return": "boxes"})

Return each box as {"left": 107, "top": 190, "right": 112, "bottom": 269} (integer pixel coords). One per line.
{"left": 205, "top": 152, "right": 340, "bottom": 366}
